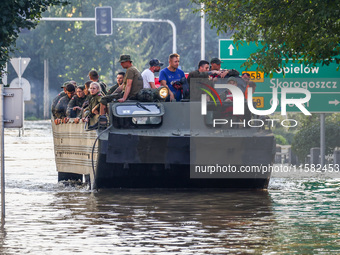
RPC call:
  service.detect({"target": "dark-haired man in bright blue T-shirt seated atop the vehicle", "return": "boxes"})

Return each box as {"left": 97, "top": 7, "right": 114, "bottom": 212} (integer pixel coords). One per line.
{"left": 159, "top": 53, "right": 185, "bottom": 101}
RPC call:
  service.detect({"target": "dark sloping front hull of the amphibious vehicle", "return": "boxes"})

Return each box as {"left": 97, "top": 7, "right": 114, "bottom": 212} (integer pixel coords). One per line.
{"left": 96, "top": 133, "right": 274, "bottom": 189}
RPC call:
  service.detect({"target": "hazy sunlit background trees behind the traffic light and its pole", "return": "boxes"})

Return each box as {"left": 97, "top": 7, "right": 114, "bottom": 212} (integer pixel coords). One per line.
{"left": 8, "top": 0, "right": 226, "bottom": 117}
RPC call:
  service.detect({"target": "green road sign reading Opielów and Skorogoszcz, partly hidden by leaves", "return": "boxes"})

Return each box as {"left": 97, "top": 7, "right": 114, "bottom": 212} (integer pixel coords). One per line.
{"left": 219, "top": 39, "right": 340, "bottom": 113}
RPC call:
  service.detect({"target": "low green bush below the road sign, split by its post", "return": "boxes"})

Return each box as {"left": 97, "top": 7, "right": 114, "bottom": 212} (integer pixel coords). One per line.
{"left": 292, "top": 117, "right": 340, "bottom": 159}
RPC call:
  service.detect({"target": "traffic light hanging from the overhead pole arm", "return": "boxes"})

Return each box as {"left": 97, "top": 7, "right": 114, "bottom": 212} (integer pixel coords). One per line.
{"left": 95, "top": 6, "right": 112, "bottom": 35}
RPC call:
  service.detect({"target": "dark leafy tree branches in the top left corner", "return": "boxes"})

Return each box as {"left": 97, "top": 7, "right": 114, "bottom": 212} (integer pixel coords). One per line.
{"left": 0, "top": 0, "right": 67, "bottom": 76}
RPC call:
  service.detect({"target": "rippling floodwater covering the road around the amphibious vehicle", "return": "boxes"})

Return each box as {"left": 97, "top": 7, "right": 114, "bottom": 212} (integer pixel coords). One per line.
{"left": 0, "top": 121, "right": 340, "bottom": 254}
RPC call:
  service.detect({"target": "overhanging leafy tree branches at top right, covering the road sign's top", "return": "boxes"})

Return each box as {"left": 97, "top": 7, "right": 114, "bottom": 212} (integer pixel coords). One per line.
{"left": 191, "top": 0, "right": 340, "bottom": 74}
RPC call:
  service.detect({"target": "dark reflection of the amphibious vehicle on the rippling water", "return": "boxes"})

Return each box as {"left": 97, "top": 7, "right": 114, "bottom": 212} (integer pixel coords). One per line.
{"left": 43, "top": 190, "right": 272, "bottom": 254}
